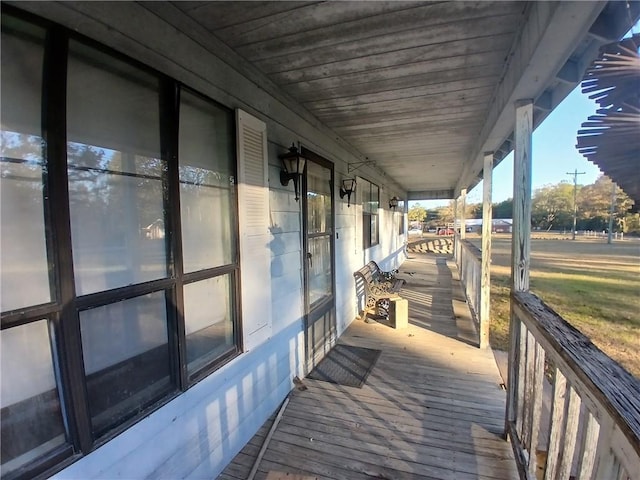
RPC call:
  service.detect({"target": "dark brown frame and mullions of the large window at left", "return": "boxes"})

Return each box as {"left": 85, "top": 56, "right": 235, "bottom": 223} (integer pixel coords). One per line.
{"left": 0, "top": 6, "right": 242, "bottom": 479}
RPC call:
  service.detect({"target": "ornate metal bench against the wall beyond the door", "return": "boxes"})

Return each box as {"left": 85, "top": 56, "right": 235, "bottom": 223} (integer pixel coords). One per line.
{"left": 353, "top": 260, "right": 405, "bottom": 321}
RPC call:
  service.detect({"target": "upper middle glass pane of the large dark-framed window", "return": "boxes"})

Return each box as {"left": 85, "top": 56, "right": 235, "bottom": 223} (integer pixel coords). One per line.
{"left": 67, "top": 41, "right": 167, "bottom": 295}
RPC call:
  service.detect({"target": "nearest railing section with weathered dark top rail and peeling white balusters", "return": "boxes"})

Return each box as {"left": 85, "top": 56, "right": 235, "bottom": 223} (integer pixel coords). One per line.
{"left": 506, "top": 292, "right": 640, "bottom": 480}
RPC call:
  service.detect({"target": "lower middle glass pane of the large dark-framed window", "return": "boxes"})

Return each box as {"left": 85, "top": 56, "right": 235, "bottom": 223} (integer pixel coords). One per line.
{"left": 80, "top": 292, "right": 173, "bottom": 436}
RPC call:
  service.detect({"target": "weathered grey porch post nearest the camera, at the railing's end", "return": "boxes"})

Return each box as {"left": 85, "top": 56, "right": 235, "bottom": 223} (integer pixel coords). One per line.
{"left": 505, "top": 99, "right": 533, "bottom": 431}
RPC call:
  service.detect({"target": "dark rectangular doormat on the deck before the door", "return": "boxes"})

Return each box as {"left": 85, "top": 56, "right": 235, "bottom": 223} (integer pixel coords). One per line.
{"left": 307, "top": 344, "right": 382, "bottom": 388}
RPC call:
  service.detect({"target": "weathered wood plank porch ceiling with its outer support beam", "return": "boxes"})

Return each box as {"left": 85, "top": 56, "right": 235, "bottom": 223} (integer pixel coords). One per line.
{"left": 174, "top": 1, "right": 636, "bottom": 199}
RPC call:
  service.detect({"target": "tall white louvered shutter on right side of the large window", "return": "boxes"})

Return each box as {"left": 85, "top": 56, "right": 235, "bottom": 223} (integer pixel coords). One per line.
{"left": 236, "top": 110, "right": 271, "bottom": 350}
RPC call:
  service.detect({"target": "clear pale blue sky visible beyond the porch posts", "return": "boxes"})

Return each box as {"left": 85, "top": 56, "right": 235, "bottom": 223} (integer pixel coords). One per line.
{"left": 416, "top": 85, "right": 601, "bottom": 208}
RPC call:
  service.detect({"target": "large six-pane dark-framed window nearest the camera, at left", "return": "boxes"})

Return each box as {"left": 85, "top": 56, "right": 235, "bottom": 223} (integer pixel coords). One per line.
{"left": 0, "top": 12, "right": 240, "bottom": 478}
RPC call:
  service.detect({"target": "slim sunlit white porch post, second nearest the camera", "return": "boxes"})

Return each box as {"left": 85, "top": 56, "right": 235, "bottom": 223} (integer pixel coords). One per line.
{"left": 480, "top": 152, "right": 493, "bottom": 348}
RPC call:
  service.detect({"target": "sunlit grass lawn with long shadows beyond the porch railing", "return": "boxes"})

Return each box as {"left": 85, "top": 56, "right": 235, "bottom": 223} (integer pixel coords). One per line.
{"left": 467, "top": 233, "right": 640, "bottom": 378}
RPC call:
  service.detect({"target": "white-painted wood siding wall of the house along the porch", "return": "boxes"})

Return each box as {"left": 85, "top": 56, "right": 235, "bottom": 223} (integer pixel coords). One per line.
{"left": 12, "top": 2, "right": 404, "bottom": 479}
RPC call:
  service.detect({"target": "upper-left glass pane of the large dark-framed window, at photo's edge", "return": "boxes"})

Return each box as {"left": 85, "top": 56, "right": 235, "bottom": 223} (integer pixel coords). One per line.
{"left": 0, "top": 15, "right": 52, "bottom": 312}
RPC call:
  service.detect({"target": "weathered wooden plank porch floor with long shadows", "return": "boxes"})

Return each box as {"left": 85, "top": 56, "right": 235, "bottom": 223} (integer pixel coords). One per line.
{"left": 219, "top": 253, "right": 518, "bottom": 480}
